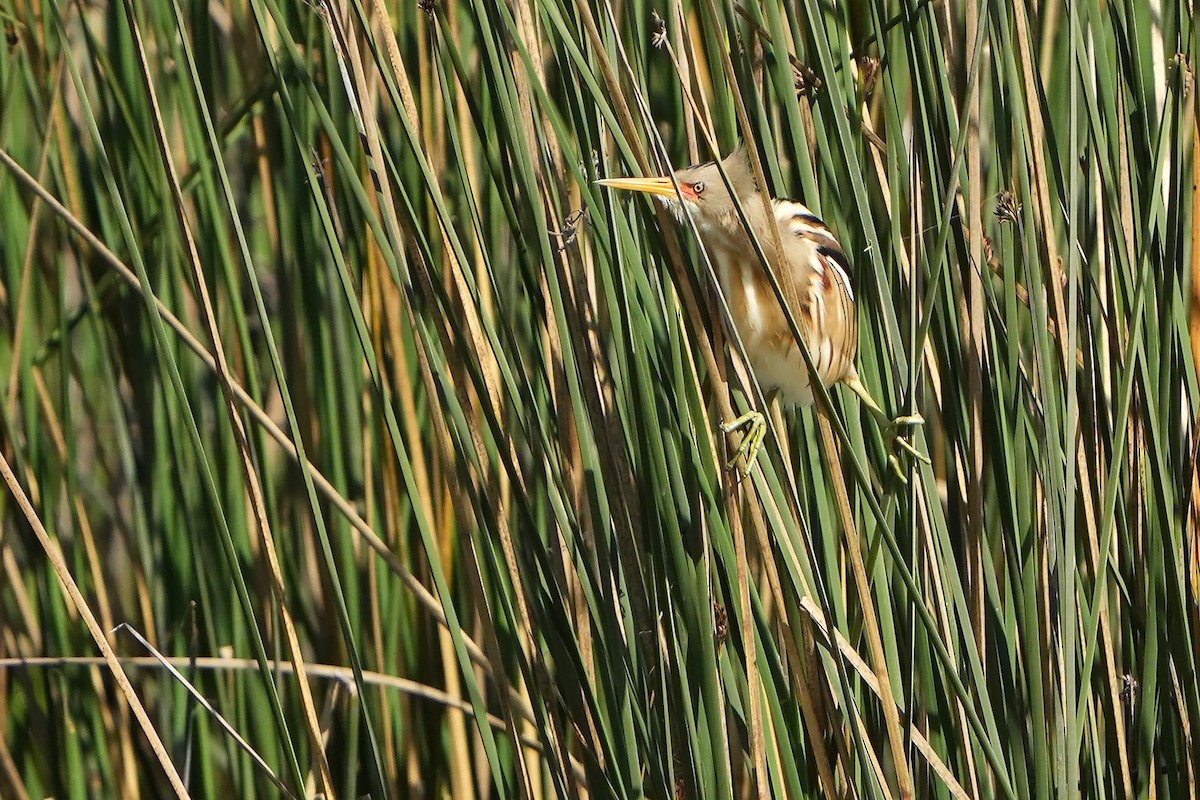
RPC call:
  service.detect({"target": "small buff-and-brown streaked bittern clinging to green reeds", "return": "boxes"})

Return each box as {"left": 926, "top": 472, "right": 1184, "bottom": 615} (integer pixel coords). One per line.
{"left": 598, "top": 149, "right": 928, "bottom": 477}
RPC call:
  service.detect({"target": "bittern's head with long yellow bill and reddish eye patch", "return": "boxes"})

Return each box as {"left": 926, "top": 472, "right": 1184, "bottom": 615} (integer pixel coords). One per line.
{"left": 596, "top": 148, "right": 761, "bottom": 233}
